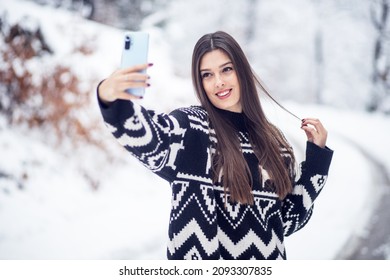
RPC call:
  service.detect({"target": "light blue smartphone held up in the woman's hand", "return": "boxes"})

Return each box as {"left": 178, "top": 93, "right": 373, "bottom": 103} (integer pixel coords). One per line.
{"left": 121, "top": 32, "right": 149, "bottom": 97}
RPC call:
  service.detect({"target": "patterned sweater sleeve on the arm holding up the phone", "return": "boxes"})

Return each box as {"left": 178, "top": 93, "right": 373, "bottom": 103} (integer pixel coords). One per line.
{"left": 98, "top": 94, "right": 188, "bottom": 181}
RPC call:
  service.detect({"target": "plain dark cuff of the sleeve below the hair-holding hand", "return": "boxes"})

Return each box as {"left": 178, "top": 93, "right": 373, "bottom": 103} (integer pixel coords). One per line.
{"left": 305, "top": 141, "right": 333, "bottom": 175}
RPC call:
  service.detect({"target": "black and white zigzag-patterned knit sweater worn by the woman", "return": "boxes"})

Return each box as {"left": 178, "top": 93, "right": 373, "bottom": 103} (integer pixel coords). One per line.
{"left": 99, "top": 100, "right": 333, "bottom": 259}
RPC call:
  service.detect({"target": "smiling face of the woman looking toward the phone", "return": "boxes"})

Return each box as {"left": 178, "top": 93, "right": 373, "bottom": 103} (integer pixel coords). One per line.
{"left": 200, "top": 49, "right": 242, "bottom": 113}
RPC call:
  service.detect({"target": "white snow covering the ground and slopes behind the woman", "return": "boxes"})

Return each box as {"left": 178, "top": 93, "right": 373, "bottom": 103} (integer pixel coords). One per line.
{"left": 0, "top": 0, "right": 390, "bottom": 259}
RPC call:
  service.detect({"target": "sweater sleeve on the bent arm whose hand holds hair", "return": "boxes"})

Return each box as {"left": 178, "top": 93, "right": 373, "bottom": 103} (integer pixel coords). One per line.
{"left": 282, "top": 142, "right": 333, "bottom": 236}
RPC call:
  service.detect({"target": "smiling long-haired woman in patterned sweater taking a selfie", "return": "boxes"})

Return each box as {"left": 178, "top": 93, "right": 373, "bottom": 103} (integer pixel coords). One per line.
{"left": 98, "top": 31, "right": 333, "bottom": 259}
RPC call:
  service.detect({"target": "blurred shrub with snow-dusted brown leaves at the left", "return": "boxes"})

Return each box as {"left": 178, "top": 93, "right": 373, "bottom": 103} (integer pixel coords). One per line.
{"left": 0, "top": 15, "right": 98, "bottom": 147}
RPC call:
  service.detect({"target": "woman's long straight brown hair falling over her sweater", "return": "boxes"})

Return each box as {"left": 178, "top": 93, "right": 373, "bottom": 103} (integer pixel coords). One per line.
{"left": 192, "top": 31, "right": 295, "bottom": 204}
